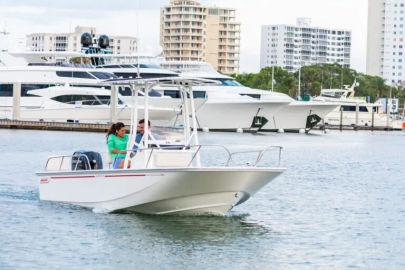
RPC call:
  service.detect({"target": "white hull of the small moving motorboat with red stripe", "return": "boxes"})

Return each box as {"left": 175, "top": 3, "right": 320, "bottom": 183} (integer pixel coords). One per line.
{"left": 38, "top": 168, "right": 285, "bottom": 215}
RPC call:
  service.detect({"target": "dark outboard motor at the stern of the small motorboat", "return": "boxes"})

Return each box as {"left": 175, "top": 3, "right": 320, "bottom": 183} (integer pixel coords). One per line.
{"left": 72, "top": 150, "right": 103, "bottom": 171}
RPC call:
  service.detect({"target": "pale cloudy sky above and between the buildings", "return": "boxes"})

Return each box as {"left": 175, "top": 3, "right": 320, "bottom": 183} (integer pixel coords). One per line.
{"left": 0, "top": 0, "right": 367, "bottom": 72}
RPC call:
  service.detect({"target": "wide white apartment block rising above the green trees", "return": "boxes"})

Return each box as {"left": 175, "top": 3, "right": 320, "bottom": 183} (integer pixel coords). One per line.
{"left": 260, "top": 18, "right": 351, "bottom": 72}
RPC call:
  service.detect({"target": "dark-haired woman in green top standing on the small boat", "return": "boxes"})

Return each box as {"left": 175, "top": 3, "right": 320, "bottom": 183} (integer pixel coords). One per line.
{"left": 107, "top": 122, "right": 128, "bottom": 169}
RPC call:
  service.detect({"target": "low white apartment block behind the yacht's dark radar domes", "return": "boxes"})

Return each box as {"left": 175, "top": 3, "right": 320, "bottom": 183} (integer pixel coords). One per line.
{"left": 27, "top": 26, "right": 137, "bottom": 54}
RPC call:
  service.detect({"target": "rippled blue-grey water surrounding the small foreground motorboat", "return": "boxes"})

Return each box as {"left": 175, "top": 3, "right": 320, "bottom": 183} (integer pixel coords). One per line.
{"left": 0, "top": 130, "right": 405, "bottom": 269}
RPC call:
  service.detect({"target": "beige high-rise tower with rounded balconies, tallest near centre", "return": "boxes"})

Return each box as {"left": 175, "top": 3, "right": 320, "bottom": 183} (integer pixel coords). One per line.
{"left": 160, "top": 0, "right": 240, "bottom": 74}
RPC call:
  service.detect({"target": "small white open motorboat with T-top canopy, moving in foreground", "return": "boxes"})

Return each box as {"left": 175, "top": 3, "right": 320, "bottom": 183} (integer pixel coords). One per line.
{"left": 37, "top": 78, "right": 285, "bottom": 215}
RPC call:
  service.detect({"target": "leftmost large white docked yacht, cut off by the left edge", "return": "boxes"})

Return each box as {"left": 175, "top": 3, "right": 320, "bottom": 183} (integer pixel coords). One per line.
{"left": 0, "top": 65, "right": 182, "bottom": 123}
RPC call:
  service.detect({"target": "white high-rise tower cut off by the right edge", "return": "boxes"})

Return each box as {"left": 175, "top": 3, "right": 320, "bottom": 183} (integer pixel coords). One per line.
{"left": 366, "top": 0, "right": 405, "bottom": 85}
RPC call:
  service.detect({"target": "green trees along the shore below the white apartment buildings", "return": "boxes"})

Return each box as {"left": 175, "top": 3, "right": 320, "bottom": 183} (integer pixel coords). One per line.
{"left": 232, "top": 64, "right": 405, "bottom": 107}
